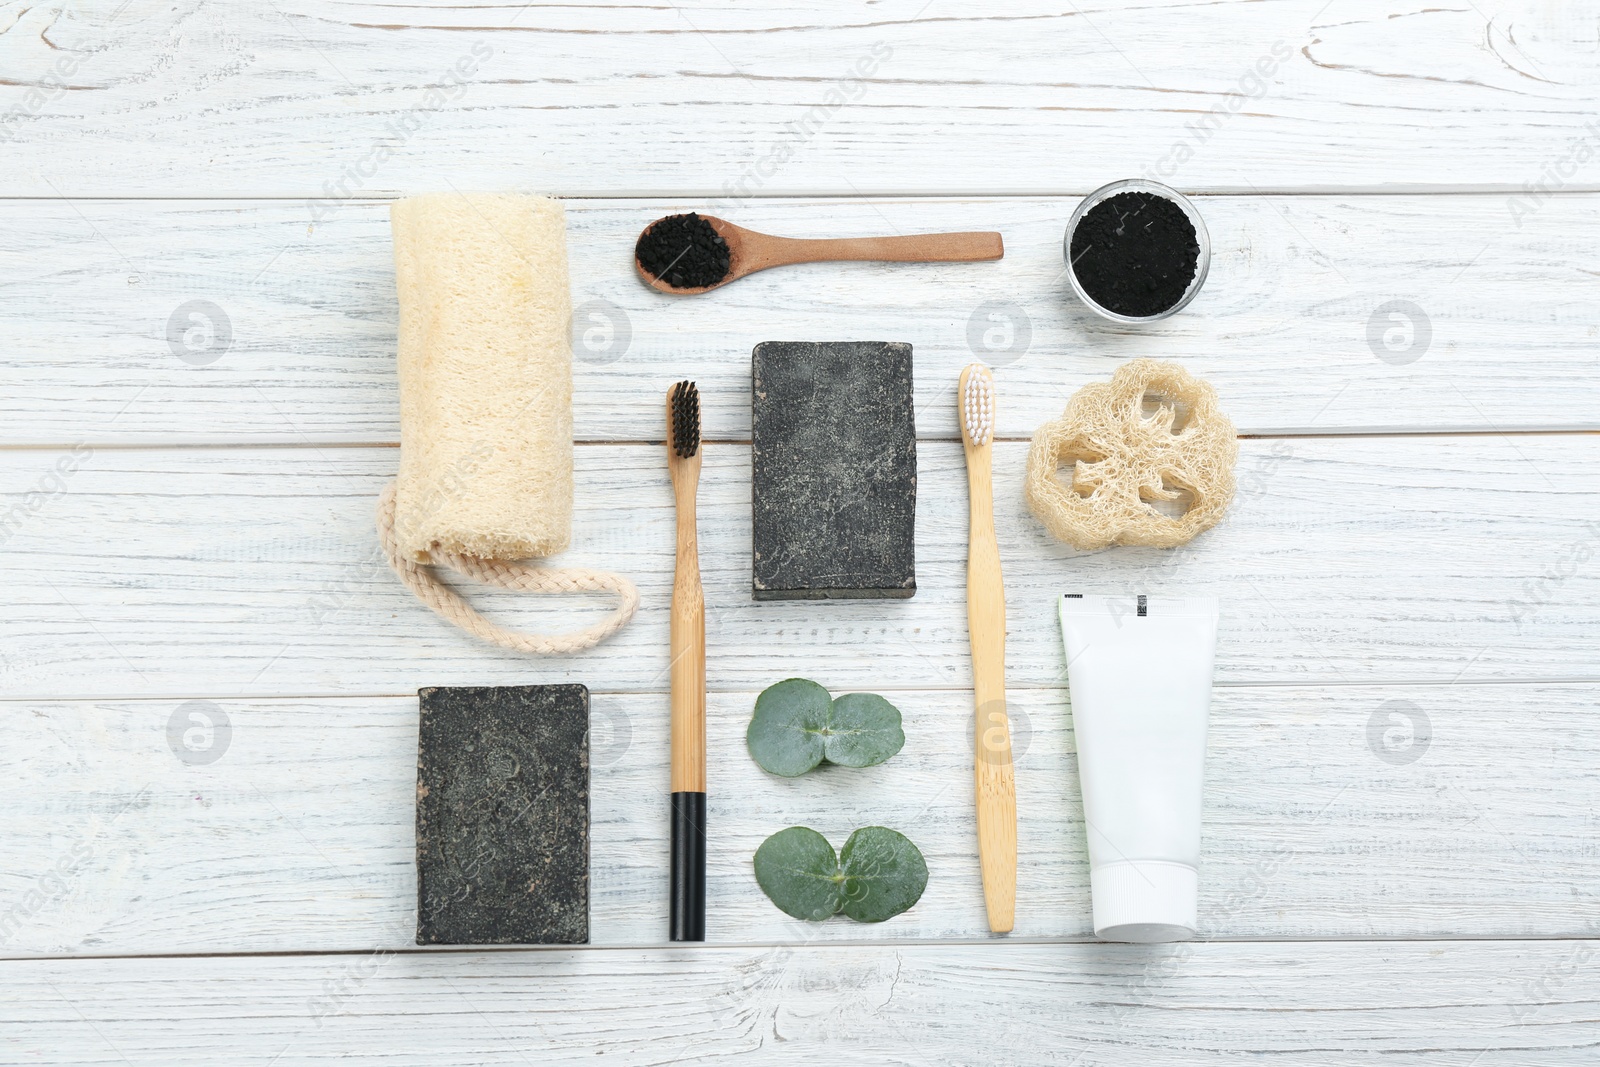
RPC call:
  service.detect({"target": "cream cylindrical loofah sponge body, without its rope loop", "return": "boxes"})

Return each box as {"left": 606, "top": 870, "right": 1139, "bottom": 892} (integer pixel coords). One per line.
{"left": 389, "top": 194, "right": 573, "bottom": 563}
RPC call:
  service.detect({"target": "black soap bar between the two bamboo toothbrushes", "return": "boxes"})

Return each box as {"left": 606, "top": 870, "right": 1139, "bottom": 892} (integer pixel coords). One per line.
{"left": 750, "top": 341, "right": 917, "bottom": 600}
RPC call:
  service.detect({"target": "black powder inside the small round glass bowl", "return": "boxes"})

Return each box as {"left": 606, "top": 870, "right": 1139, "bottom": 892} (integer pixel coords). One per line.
{"left": 1072, "top": 192, "right": 1200, "bottom": 318}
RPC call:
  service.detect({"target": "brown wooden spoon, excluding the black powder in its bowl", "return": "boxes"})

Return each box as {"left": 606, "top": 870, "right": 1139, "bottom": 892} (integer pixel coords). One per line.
{"left": 634, "top": 214, "right": 1005, "bottom": 296}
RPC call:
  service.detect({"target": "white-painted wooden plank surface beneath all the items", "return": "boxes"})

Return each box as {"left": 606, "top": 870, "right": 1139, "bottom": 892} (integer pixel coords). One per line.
{"left": 0, "top": 0, "right": 1600, "bottom": 1067}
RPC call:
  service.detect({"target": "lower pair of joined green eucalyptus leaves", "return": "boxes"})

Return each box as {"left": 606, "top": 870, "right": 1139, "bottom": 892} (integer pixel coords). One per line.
{"left": 755, "top": 825, "right": 928, "bottom": 923}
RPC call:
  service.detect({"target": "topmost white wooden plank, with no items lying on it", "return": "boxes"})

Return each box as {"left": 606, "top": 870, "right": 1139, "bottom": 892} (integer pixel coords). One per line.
{"left": 0, "top": 0, "right": 1597, "bottom": 195}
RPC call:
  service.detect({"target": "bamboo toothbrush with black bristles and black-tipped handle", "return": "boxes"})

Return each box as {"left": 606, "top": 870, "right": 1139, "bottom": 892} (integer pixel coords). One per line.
{"left": 667, "top": 382, "right": 706, "bottom": 941}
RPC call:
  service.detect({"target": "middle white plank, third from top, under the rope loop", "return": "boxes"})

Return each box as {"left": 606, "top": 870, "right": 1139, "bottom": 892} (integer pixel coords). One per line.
{"left": 0, "top": 435, "right": 1600, "bottom": 699}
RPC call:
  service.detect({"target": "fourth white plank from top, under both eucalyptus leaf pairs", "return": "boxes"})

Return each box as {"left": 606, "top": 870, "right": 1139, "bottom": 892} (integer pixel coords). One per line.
{"left": 0, "top": 684, "right": 1600, "bottom": 957}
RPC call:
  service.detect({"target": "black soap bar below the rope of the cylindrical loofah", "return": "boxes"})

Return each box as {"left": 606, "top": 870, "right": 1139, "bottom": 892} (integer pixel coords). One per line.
{"left": 416, "top": 685, "right": 589, "bottom": 945}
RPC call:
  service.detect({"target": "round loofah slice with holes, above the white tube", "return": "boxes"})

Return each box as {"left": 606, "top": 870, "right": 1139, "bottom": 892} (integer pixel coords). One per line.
{"left": 1024, "top": 360, "right": 1238, "bottom": 550}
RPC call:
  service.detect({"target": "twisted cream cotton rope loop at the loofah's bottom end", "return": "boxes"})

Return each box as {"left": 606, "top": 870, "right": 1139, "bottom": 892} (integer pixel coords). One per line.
{"left": 378, "top": 482, "right": 638, "bottom": 656}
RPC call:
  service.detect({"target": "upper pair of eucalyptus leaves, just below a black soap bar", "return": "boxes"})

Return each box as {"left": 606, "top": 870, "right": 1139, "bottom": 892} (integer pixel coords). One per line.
{"left": 744, "top": 678, "right": 906, "bottom": 777}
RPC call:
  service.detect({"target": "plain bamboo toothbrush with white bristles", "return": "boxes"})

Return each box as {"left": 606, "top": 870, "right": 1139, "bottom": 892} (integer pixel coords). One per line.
{"left": 960, "top": 363, "right": 1016, "bottom": 934}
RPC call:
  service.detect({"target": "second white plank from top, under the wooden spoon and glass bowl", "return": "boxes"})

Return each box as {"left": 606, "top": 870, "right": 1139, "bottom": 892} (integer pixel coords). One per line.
{"left": 0, "top": 197, "right": 1600, "bottom": 445}
